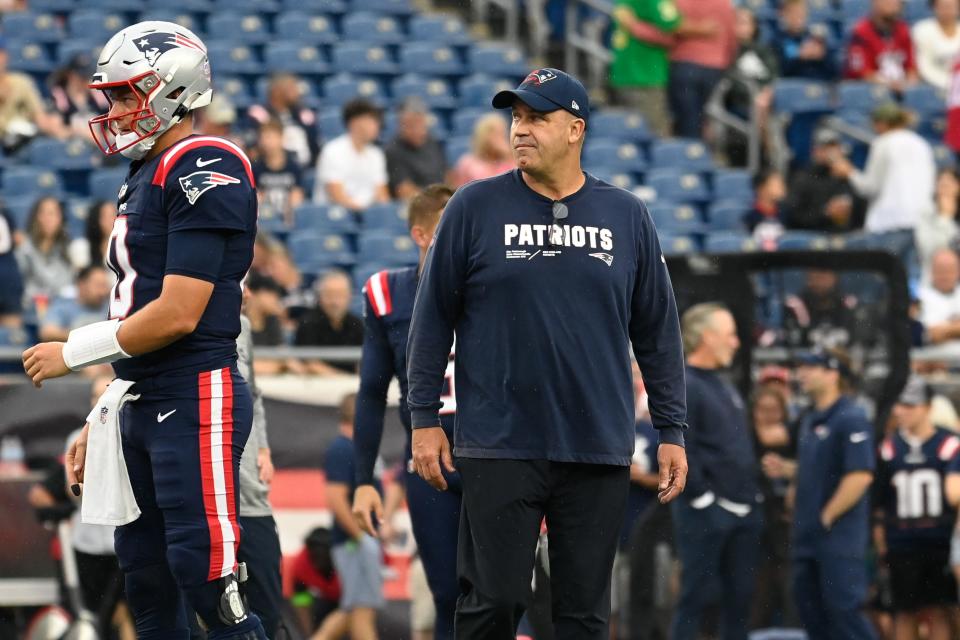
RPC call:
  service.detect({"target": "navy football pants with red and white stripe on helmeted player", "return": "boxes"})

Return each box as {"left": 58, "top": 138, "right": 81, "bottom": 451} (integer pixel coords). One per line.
{"left": 116, "top": 368, "right": 266, "bottom": 640}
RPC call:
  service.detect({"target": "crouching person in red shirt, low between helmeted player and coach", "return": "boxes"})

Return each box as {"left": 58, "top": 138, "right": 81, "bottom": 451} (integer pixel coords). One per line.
{"left": 290, "top": 527, "right": 347, "bottom": 640}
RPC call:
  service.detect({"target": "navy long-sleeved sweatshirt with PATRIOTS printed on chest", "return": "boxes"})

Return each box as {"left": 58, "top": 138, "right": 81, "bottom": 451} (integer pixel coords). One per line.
{"left": 407, "top": 170, "right": 686, "bottom": 466}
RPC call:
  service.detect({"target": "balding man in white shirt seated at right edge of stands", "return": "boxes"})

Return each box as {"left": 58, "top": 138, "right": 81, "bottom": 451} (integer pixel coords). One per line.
{"left": 920, "top": 249, "right": 960, "bottom": 343}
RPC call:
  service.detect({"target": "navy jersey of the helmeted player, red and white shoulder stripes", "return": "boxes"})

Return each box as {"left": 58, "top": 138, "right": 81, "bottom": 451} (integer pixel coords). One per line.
{"left": 107, "top": 136, "right": 257, "bottom": 380}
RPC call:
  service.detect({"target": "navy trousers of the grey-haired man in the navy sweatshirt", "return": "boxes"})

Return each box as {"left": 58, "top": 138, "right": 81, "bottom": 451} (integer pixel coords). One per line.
{"left": 670, "top": 499, "right": 763, "bottom": 640}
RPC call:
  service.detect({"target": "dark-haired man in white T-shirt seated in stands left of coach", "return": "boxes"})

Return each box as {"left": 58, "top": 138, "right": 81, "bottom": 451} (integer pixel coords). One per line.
{"left": 313, "top": 99, "right": 390, "bottom": 211}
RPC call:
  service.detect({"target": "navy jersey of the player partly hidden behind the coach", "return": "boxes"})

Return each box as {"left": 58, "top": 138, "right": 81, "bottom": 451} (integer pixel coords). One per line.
{"left": 353, "top": 267, "right": 457, "bottom": 484}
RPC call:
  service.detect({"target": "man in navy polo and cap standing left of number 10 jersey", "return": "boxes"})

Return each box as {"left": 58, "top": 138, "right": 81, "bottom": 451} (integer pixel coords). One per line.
{"left": 793, "top": 350, "right": 875, "bottom": 640}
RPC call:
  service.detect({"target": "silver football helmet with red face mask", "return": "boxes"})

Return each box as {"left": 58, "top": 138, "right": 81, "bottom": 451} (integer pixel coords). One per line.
{"left": 90, "top": 21, "right": 213, "bottom": 160}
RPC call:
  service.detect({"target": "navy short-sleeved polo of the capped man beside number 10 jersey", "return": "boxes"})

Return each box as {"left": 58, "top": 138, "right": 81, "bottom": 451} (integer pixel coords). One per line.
{"left": 793, "top": 396, "right": 876, "bottom": 558}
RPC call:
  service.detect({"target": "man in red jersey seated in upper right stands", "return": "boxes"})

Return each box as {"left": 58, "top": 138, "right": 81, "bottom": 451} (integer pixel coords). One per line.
{"left": 844, "top": 0, "right": 917, "bottom": 92}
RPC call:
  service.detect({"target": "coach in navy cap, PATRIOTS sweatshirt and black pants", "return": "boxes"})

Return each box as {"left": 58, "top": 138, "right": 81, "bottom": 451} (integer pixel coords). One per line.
{"left": 407, "top": 69, "right": 686, "bottom": 640}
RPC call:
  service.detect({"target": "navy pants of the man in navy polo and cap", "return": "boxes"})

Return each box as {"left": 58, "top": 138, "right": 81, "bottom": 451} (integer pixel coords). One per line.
{"left": 793, "top": 556, "right": 876, "bottom": 640}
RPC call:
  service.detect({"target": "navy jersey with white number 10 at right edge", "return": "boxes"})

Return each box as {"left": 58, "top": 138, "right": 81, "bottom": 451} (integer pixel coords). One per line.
{"left": 873, "top": 427, "right": 960, "bottom": 551}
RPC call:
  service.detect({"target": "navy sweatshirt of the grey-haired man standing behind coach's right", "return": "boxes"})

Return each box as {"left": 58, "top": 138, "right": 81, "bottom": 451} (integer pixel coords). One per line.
{"left": 684, "top": 366, "right": 759, "bottom": 505}
